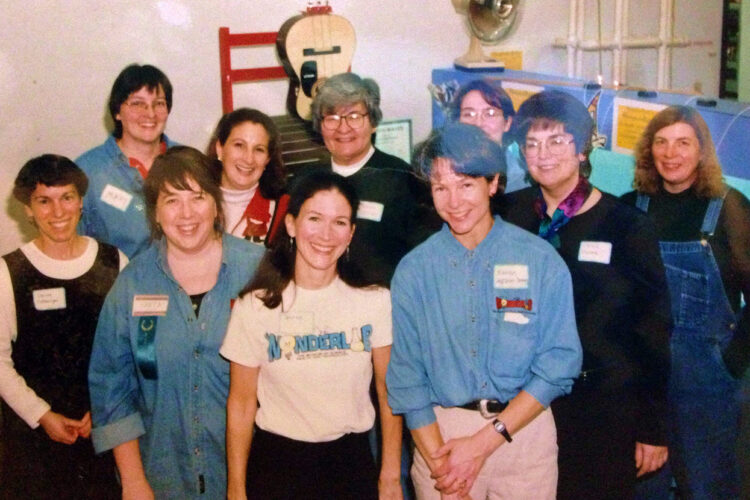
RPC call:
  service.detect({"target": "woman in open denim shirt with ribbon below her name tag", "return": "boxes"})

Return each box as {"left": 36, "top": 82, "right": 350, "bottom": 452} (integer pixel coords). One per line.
{"left": 89, "top": 147, "right": 262, "bottom": 499}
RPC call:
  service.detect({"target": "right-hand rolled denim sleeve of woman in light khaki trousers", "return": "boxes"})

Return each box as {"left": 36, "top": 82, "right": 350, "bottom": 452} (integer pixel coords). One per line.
{"left": 523, "top": 256, "right": 583, "bottom": 406}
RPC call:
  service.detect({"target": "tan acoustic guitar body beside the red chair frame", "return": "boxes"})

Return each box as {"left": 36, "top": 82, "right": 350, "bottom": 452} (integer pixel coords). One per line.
{"left": 276, "top": 1, "right": 357, "bottom": 121}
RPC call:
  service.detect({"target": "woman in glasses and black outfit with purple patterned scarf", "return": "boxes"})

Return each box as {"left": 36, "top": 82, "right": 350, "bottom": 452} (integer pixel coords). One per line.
{"left": 501, "top": 91, "right": 670, "bottom": 499}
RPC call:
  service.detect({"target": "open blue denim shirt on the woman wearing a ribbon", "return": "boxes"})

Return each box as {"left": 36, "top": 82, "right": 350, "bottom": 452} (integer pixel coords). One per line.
{"left": 89, "top": 234, "right": 263, "bottom": 499}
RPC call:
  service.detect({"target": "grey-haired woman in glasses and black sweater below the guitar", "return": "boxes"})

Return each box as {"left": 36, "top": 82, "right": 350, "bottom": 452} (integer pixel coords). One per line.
{"left": 304, "top": 73, "right": 439, "bottom": 283}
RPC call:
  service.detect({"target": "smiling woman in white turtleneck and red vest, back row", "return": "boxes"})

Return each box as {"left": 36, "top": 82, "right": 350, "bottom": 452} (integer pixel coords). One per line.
{"left": 206, "top": 108, "right": 285, "bottom": 244}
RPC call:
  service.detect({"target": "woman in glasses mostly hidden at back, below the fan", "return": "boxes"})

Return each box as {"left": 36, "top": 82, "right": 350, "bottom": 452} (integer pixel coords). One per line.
{"left": 451, "top": 80, "right": 530, "bottom": 196}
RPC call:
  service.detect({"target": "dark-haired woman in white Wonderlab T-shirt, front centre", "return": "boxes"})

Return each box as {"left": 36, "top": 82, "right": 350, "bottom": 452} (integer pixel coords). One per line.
{"left": 220, "top": 171, "right": 402, "bottom": 499}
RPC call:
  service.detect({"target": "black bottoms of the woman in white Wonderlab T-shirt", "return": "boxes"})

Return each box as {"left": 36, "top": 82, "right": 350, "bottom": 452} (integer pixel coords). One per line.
{"left": 247, "top": 427, "right": 378, "bottom": 500}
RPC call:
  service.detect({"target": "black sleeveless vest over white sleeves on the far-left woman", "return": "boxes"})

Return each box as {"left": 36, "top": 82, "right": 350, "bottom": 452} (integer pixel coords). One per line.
{"left": 3, "top": 243, "right": 120, "bottom": 418}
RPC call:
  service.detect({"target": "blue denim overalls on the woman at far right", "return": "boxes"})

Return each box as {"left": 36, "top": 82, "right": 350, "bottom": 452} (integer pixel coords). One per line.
{"left": 639, "top": 192, "right": 740, "bottom": 499}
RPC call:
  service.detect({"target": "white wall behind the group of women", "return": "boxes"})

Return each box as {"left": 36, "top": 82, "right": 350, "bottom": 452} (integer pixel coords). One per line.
{"left": 0, "top": 0, "right": 721, "bottom": 254}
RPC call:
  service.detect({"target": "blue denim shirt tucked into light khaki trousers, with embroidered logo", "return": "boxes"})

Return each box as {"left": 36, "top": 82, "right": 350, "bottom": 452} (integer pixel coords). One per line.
{"left": 386, "top": 217, "right": 582, "bottom": 429}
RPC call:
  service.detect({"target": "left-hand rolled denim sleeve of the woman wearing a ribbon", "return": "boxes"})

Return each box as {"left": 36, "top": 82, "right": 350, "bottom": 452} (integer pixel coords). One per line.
{"left": 89, "top": 269, "right": 145, "bottom": 453}
